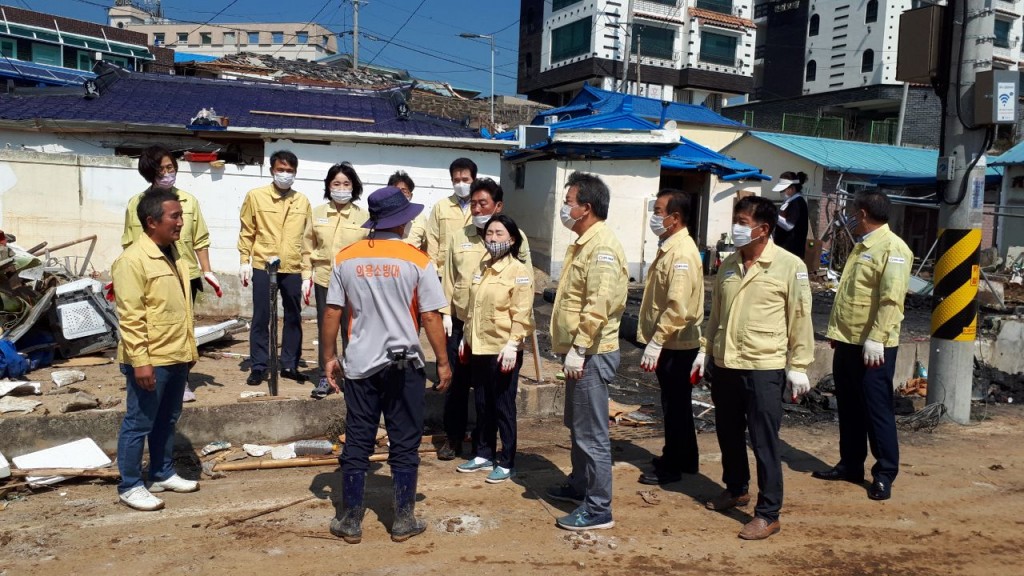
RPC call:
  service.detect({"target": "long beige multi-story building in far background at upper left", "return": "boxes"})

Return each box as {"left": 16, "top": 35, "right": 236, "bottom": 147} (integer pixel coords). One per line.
{"left": 108, "top": 0, "right": 338, "bottom": 61}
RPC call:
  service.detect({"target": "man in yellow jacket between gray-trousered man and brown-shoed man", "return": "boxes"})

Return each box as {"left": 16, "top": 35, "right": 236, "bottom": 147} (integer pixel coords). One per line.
{"left": 637, "top": 189, "right": 703, "bottom": 485}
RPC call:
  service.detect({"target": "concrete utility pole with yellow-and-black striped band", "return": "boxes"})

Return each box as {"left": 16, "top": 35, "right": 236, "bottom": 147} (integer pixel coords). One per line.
{"left": 928, "top": 0, "right": 991, "bottom": 424}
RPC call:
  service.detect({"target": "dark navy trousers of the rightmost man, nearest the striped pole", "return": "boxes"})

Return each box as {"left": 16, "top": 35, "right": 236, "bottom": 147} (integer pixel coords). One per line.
{"left": 833, "top": 342, "right": 899, "bottom": 484}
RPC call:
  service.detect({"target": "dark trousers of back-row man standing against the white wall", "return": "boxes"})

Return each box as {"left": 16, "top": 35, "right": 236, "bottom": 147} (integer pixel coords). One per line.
{"left": 249, "top": 270, "right": 302, "bottom": 370}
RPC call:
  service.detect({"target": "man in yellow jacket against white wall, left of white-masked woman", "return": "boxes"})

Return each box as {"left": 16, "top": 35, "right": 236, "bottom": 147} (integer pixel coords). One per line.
{"left": 239, "top": 150, "right": 312, "bottom": 386}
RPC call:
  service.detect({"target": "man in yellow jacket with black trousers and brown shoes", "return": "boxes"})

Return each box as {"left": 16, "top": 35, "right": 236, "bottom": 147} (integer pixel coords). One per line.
{"left": 692, "top": 196, "right": 814, "bottom": 540}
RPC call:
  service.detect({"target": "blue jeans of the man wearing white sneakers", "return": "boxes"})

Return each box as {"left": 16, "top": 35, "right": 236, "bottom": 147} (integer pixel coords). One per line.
{"left": 118, "top": 364, "right": 188, "bottom": 487}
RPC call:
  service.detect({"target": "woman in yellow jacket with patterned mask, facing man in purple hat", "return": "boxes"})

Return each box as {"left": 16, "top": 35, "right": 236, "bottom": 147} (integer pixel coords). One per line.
{"left": 457, "top": 214, "right": 534, "bottom": 484}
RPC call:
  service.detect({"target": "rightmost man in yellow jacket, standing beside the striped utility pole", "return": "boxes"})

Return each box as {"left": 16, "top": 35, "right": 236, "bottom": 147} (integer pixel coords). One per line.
{"left": 812, "top": 191, "right": 913, "bottom": 500}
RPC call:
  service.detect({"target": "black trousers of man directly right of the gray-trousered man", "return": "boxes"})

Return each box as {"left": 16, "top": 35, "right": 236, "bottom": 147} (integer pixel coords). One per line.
{"left": 654, "top": 348, "right": 700, "bottom": 474}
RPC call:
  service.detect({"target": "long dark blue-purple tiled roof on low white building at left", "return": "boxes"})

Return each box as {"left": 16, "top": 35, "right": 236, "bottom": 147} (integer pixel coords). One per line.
{"left": 0, "top": 73, "right": 480, "bottom": 138}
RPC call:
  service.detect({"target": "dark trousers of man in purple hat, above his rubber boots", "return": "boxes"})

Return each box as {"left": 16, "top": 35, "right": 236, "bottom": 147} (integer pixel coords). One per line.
{"left": 338, "top": 365, "right": 427, "bottom": 474}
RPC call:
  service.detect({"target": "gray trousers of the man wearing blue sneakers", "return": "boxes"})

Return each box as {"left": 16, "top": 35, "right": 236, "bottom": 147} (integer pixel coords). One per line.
{"left": 564, "top": 351, "right": 618, "bottom": 516}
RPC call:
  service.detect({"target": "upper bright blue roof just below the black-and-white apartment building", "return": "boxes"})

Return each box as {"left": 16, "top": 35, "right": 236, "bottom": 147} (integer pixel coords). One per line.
{"left": 534, "top": 85, "right": 744, "bottom": 128}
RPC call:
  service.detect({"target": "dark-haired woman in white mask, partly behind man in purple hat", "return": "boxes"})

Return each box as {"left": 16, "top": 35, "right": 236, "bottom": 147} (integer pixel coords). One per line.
{"left": 302, "top": 162, "right": 370, "bottom": 398}
